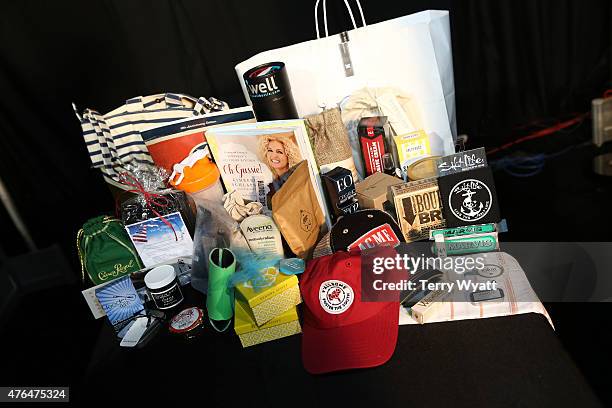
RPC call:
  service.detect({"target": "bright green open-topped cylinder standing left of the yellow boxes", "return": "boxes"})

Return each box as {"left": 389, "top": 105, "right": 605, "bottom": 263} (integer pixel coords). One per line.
{"left": 206, "top": 248, "right": 236, "bottom": 323}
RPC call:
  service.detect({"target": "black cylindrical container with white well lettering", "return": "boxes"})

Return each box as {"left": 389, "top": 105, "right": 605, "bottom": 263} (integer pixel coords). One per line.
{"left": 243, "top": 62, "right": 298, "bottom": 121}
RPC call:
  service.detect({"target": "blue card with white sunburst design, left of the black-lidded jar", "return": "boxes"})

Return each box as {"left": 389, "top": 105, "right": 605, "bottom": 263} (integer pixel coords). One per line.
{"left": 96, "top": 276, "right": 144, "bottom": 326}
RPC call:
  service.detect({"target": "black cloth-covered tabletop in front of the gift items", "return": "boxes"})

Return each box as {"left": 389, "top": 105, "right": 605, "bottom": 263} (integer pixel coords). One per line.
{"left": 83, "top": 306, "right": 599, "bottom": 407}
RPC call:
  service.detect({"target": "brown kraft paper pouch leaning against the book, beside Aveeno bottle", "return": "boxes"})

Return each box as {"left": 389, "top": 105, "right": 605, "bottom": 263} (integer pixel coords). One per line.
{"left": 272, "top": 160, "right": 325, "bottom": 259}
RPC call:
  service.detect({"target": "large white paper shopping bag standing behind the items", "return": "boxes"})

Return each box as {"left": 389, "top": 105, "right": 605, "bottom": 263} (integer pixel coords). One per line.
{"left": 236, "top": 1, "right": 457, "bottom": 176}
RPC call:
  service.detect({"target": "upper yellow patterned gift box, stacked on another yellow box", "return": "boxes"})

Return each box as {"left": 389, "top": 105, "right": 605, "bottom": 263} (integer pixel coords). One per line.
{"left": 235, "top": 267, "right": 302, "bottom": 326}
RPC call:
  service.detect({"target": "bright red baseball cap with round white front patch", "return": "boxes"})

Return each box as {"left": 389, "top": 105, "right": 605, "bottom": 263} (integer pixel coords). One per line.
{"left": 300, "top": 251, "right": 399, "bottom": 374}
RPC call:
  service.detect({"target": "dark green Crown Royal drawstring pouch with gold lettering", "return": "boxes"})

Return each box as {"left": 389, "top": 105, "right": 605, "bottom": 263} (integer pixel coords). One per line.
{"left": 77, "top": 216, "right": 142, "bottom": 285}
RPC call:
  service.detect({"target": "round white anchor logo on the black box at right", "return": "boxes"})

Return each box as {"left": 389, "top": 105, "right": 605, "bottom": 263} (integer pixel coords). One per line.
{"left": 448, "top": 179, "right": 493, "bottom": 222}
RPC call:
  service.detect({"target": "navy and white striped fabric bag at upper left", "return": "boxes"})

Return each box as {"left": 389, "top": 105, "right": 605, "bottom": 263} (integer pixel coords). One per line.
{"left": 75, "top": 93, "right": 229, "bottom": 181}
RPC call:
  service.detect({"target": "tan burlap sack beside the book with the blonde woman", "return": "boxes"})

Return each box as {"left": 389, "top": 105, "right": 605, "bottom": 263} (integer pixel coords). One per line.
{"left": 304, "top": 108, "right": 359, "bottom": 180}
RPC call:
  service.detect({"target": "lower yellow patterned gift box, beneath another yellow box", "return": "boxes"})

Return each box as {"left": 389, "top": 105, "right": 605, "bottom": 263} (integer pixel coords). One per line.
{"left": 234, "top": 299, "right": 302, "bottom": 347}
